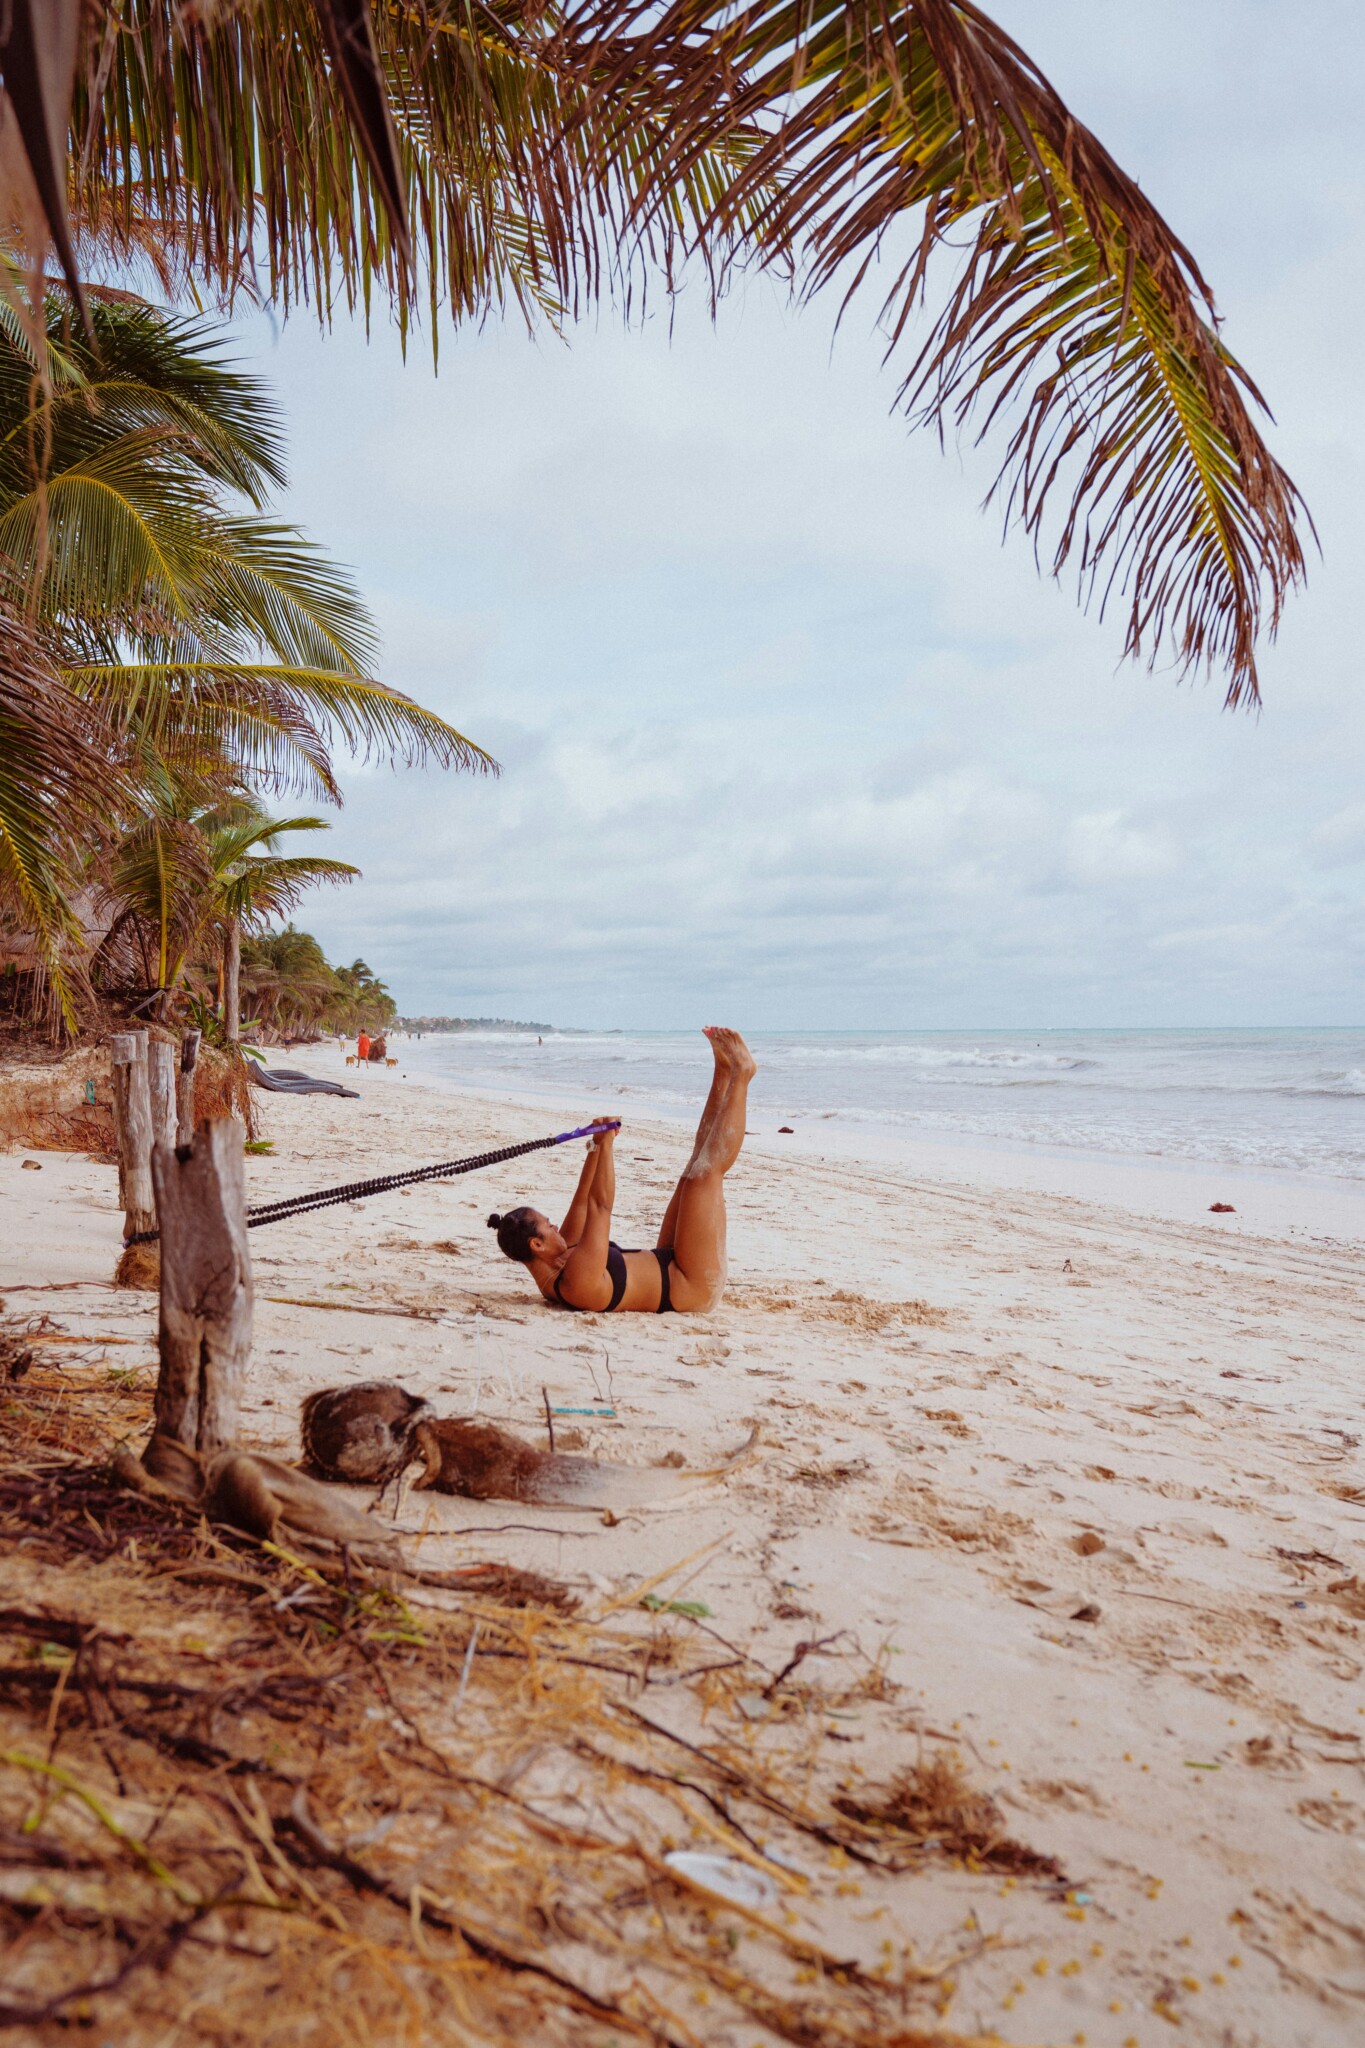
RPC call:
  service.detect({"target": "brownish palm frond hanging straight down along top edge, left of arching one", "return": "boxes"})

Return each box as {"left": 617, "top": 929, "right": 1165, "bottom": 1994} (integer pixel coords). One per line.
{"left": 72, "top": 0, "right": 769, "bottom": 324}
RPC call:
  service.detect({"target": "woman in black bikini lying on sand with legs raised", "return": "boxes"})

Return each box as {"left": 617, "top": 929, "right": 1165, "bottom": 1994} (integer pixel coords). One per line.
{"left": 489, "top": 1024, "right": 755, "bottom": 1315}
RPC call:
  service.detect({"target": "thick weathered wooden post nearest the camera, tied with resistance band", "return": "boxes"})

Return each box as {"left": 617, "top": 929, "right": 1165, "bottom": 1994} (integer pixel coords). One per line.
{"left": 151, "top": 1116, "right": 252, "bottom": 1454}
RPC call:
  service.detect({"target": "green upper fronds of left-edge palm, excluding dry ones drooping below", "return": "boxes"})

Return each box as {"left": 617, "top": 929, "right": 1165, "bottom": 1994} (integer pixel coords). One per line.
{"left": 0, "top": 299, "right": 491, "bottom": 801}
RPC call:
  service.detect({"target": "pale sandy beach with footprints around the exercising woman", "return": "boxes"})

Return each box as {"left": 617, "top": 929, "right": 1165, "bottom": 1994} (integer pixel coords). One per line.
{"left": 0, "top": 1049, "right": 1365, "bottom": 2048}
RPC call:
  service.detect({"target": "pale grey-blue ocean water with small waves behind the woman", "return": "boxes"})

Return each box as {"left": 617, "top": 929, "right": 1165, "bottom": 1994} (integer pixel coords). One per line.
{"left": 395, "top": 1028, "right": 1365, "bottom": 1182}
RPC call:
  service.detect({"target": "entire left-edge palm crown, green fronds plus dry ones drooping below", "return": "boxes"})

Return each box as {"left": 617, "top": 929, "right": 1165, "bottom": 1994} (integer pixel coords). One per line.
{"left": 0, "top": 284, "right": 493, "bottom": 1024}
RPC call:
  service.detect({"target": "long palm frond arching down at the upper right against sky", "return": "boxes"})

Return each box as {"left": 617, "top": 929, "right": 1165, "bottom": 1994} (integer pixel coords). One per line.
{"left": 565, "top": 0, "right": 1304, "bottom": 705}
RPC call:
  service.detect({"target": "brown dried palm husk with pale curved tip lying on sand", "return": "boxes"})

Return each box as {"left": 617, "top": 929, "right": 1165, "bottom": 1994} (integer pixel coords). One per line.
{"left": 415, "top": 1419, "right": 757, "bottom": 1509}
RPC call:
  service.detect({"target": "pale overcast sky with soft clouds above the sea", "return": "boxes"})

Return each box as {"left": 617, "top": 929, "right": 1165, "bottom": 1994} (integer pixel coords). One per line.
{"left": 229, "top": 0, "right": 1365, "bottom": 1028}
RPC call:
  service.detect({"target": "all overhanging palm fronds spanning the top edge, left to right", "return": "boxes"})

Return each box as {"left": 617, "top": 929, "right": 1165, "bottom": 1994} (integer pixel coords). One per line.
{"left": 0, "top": 0, "right": 1304, "bottom": 702}
